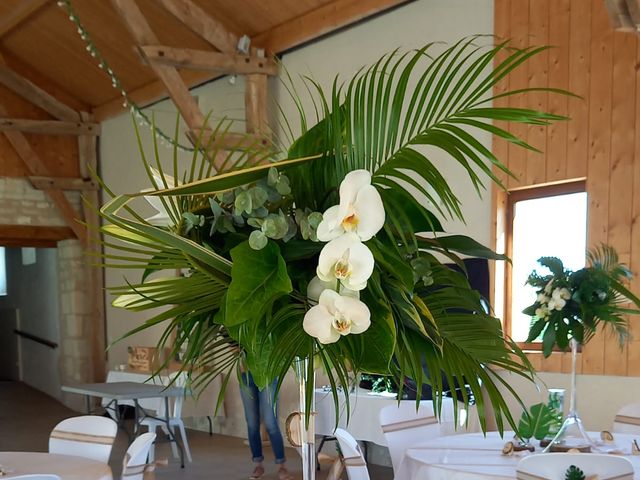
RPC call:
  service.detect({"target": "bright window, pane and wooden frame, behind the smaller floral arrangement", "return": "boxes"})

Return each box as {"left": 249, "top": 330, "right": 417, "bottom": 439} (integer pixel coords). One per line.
{"left": 504, "top": 181, "right": 587, "bottom": 342}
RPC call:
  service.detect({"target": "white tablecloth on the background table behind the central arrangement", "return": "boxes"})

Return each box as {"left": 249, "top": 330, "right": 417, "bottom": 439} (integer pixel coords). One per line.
{"left": 315, "top": 388, "right": 478, "bottom": 446}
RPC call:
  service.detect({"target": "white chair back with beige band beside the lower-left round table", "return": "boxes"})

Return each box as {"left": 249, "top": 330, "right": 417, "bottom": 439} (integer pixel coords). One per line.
{"left": 49, "top": 415, "right": 118, "bottom": 463}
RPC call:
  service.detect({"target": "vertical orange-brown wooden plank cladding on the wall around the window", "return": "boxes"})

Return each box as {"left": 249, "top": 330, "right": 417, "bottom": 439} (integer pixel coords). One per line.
{"left": 493, "top": 0, "right": 640, "bottom": 375}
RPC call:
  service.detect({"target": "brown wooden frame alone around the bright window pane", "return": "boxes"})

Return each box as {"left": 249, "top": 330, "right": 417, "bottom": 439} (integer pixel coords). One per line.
{"left": 502, "top": 179, "right": 589, "bottom": 351}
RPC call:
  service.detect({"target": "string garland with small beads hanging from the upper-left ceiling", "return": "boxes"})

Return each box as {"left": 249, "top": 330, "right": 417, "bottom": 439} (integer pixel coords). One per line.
{"left": 58, "top": 0, "right": 194, "bottom": 152}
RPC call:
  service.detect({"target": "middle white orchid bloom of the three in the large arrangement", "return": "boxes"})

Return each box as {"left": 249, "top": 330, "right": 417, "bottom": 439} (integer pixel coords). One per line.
{"left": 316, "top": 233, "right": 375, "bottom": 290}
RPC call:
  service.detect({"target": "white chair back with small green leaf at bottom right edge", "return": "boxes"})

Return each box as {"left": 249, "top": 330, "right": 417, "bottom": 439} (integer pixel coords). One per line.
{"left": 516, "top": 453, "right": 633, "bottom": 480}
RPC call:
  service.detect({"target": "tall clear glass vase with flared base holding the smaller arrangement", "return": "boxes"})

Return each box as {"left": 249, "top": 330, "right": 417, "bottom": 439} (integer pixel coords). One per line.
{"left": 544, "top": 338, "right": 595, "bottom": 453}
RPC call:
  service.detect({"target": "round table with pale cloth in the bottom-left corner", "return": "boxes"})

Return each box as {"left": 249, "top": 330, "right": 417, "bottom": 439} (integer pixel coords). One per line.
{"left": 0, "top": 452, "right": 113, "bottom": 480}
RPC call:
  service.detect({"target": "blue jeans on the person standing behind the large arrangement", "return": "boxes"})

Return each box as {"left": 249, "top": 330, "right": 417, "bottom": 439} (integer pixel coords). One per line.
{"left": 240, "top": 373, "right": 286, "bottom": 464}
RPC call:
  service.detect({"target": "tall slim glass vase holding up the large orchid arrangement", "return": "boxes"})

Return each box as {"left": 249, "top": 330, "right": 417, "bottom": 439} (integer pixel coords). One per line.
{"left": 294, "top": 358, "right": 316, "bottom": 480}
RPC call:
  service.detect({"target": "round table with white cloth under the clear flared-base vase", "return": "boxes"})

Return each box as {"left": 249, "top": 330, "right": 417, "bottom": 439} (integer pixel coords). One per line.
{"left": 395, "top": 432, "right": 640, "bottom": 480}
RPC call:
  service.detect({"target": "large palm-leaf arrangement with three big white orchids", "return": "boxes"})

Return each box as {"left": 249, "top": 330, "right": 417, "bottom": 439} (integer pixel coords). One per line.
{"left": 101, "top": 37, "right": 563, "bottom": 428}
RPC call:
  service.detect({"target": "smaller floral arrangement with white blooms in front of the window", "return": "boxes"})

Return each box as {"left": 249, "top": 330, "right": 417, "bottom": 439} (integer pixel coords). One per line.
{"left": 523, "top": 246, "right": 640, "bottom": 357}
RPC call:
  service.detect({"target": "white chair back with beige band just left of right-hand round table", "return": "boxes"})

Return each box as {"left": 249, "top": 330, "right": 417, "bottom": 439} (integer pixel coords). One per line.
{"left": 380, "top": 400, "right": 441, "bottom": 472}
